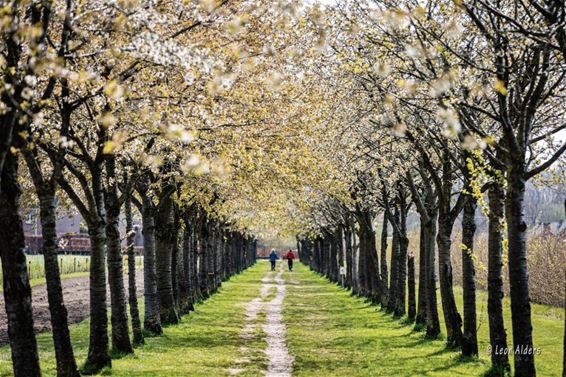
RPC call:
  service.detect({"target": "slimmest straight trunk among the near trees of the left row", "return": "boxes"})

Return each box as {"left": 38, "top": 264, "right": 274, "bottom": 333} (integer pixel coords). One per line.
{"left": 124, "top": 194, "right": 144, "bottom": 346}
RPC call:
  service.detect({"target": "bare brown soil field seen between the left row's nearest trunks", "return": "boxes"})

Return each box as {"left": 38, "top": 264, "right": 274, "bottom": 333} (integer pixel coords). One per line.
{"left": 0, "top": 270, "right": 143, "bottom": 344}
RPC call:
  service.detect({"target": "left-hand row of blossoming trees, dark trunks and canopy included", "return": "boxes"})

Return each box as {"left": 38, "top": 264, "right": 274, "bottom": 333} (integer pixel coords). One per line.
{"left": 0, "top": 0, "right": 332, "bottom": 377}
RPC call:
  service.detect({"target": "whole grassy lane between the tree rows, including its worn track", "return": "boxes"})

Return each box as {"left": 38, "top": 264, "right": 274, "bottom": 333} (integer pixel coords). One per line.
{"left": 0, "top": 261, "right": 563, "bottom": 377}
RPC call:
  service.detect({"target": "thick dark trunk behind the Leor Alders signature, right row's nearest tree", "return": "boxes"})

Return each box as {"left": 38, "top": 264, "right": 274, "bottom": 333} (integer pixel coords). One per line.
{"left": 505, "top": 166, "right": 536, "bottom": 377}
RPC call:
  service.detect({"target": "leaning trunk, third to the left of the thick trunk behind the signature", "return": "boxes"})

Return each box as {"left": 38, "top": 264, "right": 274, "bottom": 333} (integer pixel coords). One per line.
{"left": 436, "top": 213, "right": 462, "bottom": 347}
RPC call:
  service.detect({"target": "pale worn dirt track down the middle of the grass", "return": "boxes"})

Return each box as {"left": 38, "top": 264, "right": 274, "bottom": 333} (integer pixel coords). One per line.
{"left": 234, "top": 264, "right": 294, "bottom": 377}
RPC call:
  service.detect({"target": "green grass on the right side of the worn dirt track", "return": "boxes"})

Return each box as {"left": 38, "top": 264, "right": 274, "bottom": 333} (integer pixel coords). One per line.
{"left": 284, "top": 265, "right": 564, "bottom": 377}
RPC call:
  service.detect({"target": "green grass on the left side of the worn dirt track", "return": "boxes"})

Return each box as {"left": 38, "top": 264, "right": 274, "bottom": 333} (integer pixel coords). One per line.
{"left": 0, "top": 265, "right": 265, "bottom": 377}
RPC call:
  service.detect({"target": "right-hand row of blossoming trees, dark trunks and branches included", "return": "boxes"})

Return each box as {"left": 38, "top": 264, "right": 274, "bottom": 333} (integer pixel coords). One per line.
{"left": 292, "top": 0, "right": 566, "bottom": 376}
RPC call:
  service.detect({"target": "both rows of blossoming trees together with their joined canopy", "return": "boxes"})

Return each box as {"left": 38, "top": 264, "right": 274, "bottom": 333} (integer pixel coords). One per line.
{"left": 0, "top": 0, "right": 566, "bottom": 376}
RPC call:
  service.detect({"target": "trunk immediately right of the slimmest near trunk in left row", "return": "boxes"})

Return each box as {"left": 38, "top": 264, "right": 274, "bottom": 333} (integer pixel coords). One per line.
{"left": 142, "top": 192, "right": 163, "bottom": 335}
